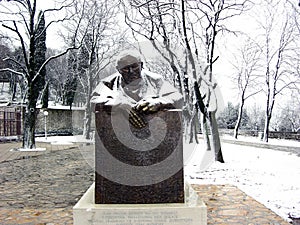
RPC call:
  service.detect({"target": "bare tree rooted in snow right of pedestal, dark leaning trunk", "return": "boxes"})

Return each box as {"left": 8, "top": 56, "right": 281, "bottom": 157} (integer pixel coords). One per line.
{"left": 192, "top": 0, "right": 251, "bottom": 161}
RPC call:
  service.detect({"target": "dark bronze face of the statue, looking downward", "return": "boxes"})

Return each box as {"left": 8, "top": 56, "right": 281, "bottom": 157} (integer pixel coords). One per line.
{"left": 118, "top": 63, "right": 142, "bottom": 84}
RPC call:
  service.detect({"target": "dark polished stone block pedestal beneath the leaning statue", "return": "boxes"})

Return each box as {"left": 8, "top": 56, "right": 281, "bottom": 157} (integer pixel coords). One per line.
{"left": 95, "top": 104, "right": 184, "bottom": 204}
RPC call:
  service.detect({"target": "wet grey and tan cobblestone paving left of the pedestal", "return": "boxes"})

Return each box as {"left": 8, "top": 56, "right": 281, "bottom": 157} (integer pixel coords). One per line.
{"left": 0, "top": 147, "right": 94, "bottom": 225}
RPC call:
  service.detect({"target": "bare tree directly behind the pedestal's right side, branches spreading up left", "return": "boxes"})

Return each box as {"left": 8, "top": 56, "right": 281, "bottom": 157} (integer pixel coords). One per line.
{"left": 123, "top": 1, "right": 204, "bottom": 146}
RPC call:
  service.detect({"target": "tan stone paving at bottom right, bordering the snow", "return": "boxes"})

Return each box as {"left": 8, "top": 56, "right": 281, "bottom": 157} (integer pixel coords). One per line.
{"left": 193, "top": 185, "right": 289, "bottom": 225}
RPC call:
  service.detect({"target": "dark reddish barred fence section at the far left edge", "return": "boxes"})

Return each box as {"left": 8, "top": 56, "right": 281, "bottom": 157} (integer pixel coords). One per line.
{"left": 0, "top": 107, "right": 22, "bottom": 136}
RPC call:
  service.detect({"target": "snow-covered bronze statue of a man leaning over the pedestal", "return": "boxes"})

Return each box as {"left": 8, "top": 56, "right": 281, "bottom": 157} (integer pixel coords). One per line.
{"left": 91, "top": 54, "right": 183, "bottom": 128}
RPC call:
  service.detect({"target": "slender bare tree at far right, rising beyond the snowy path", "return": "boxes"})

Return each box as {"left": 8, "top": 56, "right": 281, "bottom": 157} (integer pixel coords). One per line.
{"left": 255, "top": 1, "right": 299, "bottom": 142}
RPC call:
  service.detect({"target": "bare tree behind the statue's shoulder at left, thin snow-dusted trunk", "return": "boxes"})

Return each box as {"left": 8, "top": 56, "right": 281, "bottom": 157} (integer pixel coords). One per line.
{"left": 66, "top": 0, "right": 122, "bottom": 139}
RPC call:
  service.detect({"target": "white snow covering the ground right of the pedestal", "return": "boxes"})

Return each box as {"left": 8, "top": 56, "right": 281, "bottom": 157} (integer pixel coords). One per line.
{"left": 185, "top": 138, "right": 300, "bottom": 221}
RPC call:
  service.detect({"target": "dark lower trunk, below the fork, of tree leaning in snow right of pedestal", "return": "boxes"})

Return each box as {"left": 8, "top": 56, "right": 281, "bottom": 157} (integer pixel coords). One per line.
{"left": 208, "top": 112, "right": 224, "bottom": 163}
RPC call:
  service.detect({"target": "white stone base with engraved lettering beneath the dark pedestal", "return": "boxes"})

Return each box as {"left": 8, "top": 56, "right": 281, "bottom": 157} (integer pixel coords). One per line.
{"left": 73, "top": 184, "right": 207, "bottom": 225}
